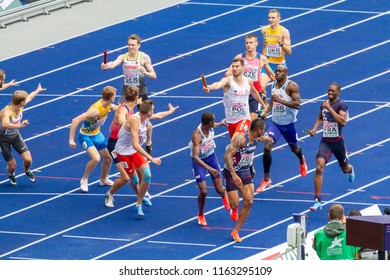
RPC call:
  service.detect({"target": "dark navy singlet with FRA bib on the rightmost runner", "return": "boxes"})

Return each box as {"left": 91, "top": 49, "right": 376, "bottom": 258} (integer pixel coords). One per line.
{"left": 321, "top": 99, "right": 348, "bottom": 142}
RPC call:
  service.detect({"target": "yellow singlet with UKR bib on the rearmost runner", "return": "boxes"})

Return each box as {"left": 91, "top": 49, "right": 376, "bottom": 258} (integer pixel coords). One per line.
{"left": 263, "top": 25, "right": 284, "bottom": 63}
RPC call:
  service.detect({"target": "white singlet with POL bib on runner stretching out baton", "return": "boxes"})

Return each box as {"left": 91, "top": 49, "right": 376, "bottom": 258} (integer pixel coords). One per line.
{"left": 223, "top": 76, "right": 251, "bottom": 124}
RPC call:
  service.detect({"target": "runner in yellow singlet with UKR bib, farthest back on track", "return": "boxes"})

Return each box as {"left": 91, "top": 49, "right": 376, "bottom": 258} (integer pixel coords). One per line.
{"left": 260, "top": 9, "right": 291, "bottom": 105}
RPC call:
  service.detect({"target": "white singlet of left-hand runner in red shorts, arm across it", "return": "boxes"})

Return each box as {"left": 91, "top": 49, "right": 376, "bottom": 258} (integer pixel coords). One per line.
{"left": 115, "top": 113, "right": 149, "bottom": 156}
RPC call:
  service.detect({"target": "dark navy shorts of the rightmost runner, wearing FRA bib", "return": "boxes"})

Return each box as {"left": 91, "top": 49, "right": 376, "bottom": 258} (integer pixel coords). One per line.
{"left": 316, "top": 138, "right": 348, "bottom": 168}
